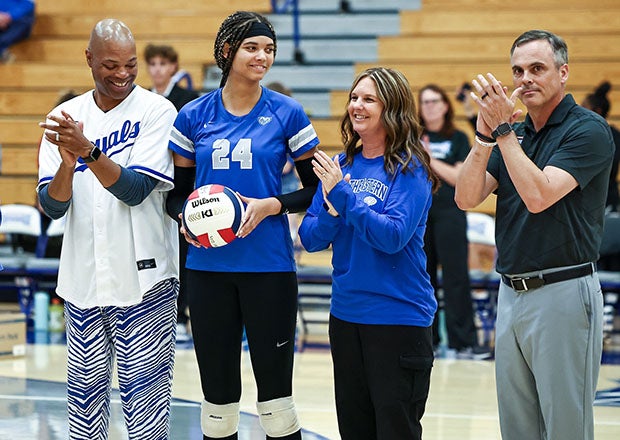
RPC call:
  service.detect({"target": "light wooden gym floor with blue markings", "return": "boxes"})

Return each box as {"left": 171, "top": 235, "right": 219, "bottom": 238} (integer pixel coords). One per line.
{"left": 0, "top": 324, "right": 620, "bottom": 440}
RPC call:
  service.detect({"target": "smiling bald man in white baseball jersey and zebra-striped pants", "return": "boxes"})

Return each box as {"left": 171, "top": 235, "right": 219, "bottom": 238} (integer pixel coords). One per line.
{"left": 37, "top": 19, "right": 178, "bottom": 440}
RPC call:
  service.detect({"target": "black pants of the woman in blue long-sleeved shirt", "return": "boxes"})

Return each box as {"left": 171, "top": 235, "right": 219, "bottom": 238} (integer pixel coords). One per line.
{"left": 329, "top": 316, "right": 433, "bottom": 440}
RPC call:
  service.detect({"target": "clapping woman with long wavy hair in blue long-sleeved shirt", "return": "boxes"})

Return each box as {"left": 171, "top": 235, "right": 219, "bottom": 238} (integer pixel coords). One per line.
{"left": 299, "top": 67, "right": 438, "bottom": 440}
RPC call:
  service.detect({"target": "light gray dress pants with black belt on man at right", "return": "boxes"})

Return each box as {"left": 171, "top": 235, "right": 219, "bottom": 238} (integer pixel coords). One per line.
{"left": 495, "top": 273, "right": 603, "bottom": 440}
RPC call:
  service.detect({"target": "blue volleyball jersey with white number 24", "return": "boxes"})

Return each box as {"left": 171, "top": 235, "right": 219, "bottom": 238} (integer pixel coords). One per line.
{"left": 169, "top": 87, "right": 319, "bottom": 272}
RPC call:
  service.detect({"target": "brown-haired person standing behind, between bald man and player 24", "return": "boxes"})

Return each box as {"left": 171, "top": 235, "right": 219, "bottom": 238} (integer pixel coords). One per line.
{"left": 144, "top": 44, "right": 198, "bottom": 342}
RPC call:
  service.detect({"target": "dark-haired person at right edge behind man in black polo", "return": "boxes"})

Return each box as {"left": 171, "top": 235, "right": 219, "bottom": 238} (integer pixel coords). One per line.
{"left": 581, "top": 81, "right": 620, "bottom": 212}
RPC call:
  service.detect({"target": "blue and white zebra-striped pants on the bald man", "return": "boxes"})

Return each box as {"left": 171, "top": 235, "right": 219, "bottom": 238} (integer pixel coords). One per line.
{"left": 65, "top": 279, "right": 179, "bottom": 440}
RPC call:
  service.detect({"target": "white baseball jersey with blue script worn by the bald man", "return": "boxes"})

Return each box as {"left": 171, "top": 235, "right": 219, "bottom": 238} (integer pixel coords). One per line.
{"left": 37, "top": 86, "right": 178, "bottom": 308}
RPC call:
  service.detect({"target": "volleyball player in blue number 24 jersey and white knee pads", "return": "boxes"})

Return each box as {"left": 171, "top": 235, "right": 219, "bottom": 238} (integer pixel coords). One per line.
{"left": 167, "top": 12, "right": 319, "bottom": 439}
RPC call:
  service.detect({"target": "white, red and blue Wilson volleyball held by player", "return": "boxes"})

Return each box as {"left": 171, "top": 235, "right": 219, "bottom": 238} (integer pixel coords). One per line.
{"left": 182, "top": 184, "right": 245, "bottom": 248}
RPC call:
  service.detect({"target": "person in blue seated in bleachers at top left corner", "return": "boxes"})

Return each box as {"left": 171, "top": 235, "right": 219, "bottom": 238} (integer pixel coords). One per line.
{"left": 0, "top": 0, "right": 35, "bottom": 64}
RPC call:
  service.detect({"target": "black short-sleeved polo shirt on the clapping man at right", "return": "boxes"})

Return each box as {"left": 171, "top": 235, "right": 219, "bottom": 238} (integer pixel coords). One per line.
{"left": 487, "top": 95, "right": 614, "bottom": 274}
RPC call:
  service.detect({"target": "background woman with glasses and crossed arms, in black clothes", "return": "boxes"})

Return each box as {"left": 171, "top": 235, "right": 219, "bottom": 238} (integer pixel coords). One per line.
{"left": 418, "top": 84, "right": 488, "bottom": 358}
